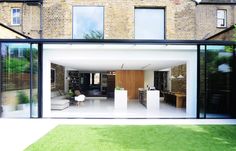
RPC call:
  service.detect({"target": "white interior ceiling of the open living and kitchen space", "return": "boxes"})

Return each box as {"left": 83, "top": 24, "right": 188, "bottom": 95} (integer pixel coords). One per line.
{"left": 52, "top": 60, "right": 186, "bottom": 71}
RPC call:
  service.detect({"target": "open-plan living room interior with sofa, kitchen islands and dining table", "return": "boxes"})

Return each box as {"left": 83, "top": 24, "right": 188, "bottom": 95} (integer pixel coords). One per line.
{"left": 51, "top": 61, "right": 186, "bottom": 118}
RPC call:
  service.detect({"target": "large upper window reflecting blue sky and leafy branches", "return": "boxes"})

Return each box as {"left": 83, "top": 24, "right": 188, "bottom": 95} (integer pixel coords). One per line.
{"left": 73, "top": 6, "right": 104, "bottom": 39}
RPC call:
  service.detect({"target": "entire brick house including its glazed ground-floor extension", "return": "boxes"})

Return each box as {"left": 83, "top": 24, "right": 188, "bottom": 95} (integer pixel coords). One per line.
{"left": 0, "top": 0, "right": 236, "bottom": 118}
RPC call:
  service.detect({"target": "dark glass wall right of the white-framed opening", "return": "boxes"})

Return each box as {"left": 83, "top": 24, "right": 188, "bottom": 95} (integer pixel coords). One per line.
{"left": 200, "top": 45, "right": 235, "bottom": 118}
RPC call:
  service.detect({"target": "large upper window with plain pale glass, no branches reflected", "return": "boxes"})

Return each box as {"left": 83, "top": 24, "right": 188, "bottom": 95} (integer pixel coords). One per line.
{"left": 135, "top": 9, "right": 165, "bottom": 39}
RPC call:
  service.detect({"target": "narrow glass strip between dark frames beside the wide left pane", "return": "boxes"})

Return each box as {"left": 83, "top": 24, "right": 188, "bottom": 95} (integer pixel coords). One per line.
{"left": 31, "top": 44, "right": 39, "bottom": 117}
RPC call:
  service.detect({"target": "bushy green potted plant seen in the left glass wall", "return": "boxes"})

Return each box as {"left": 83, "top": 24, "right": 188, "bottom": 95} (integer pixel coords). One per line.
{"left": 17, "top": 91, "right": 30, "bottom": 110}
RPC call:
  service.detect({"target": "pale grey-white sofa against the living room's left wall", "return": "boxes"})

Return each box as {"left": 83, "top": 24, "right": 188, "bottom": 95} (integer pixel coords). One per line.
{"left": 51, "top": 91, "right": 70, "bottom": 110}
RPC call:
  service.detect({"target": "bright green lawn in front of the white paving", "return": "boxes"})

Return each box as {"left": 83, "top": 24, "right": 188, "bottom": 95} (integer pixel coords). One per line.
{"left": 25, "top": 125, "right": 236, "bottom": 151}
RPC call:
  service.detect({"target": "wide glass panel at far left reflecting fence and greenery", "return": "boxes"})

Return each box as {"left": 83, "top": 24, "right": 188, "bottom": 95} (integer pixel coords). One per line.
{"left": 1, "top": 43, "right": 30, "bottom": 117}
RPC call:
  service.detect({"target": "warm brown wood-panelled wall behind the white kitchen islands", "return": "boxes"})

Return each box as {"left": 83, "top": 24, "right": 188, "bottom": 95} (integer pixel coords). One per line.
{"left": 115, "top": 70, "right": 144, "bottom": 100}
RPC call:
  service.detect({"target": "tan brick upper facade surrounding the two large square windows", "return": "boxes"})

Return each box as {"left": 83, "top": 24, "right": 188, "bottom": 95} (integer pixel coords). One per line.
{"left": 0, "top": 0, "right": 236, "bottom": 40}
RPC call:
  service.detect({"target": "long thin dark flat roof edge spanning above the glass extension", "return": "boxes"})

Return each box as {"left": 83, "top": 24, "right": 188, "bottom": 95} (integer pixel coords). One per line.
{"left": 0, "top": 39, "right": 236, "bottom": 45}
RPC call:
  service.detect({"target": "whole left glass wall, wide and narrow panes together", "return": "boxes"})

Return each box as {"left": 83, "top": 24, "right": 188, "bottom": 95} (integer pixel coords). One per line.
{"left": 1, "top": 43, "right": 38, "bottom": 118}
